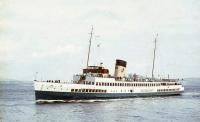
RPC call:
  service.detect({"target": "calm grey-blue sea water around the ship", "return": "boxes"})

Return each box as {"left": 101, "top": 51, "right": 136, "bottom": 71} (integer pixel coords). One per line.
{"left": 0, "top": 81, "right": 200, "bottom": 122}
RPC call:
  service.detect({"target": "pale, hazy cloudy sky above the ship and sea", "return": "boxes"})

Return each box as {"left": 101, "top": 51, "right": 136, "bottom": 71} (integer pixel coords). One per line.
{"left": 0, "top": 0, "right": 200, "bottom": 81}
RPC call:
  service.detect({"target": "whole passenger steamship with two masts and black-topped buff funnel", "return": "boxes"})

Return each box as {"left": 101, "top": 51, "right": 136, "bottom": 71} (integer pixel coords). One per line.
{"left": 34, "top": 28, "right": 184, "bottom": 101}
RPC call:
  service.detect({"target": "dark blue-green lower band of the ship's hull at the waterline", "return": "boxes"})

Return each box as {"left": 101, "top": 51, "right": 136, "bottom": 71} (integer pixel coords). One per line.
{"left": 35, "top": 91, "right": 182, "bottom": 100}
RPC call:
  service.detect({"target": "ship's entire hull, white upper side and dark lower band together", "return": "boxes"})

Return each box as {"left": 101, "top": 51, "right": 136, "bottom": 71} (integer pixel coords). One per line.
{"left": 34, "top": 81, "right": 184, "bottom": 100}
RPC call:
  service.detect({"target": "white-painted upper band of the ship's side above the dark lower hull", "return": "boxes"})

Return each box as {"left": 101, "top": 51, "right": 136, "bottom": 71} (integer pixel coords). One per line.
{"left": 34, "top": 78, "right": 184, "bottom": 93}
